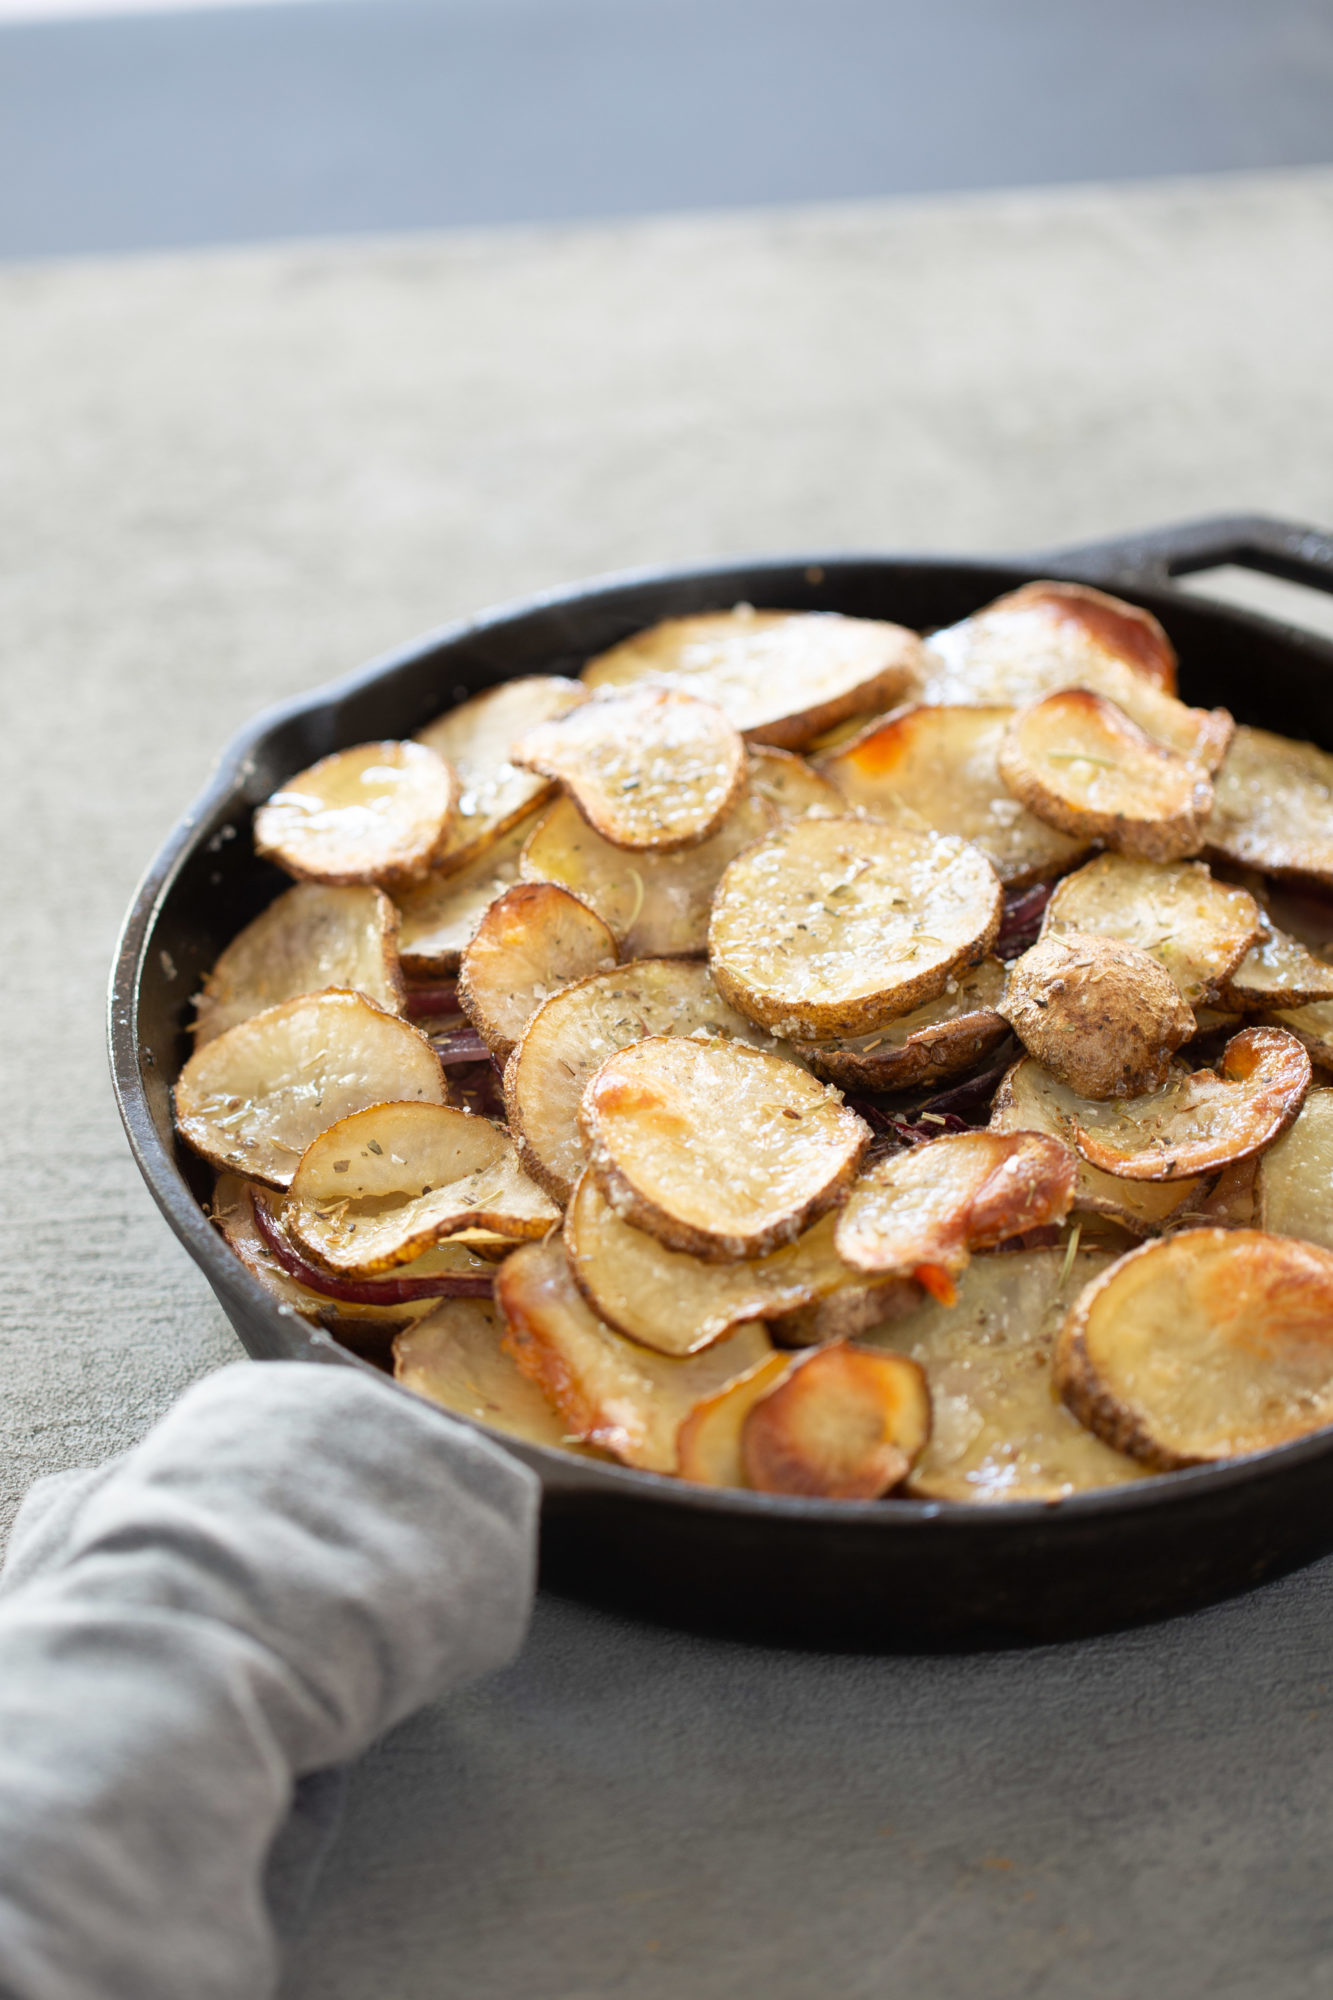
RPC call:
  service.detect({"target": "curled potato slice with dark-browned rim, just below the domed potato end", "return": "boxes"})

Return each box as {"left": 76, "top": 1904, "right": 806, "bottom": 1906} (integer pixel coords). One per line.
{"left": 1073, "top": 1028, "right": 1311, "bottom": 1180}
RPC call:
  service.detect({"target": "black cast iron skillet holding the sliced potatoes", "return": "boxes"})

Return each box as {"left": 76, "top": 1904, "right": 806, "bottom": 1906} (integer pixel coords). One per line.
{"left": 110, "top": 520, "right": 1333, "bottom": 1648}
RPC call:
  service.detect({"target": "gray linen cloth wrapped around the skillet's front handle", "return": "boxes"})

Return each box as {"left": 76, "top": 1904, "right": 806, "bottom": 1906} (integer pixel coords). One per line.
{"left": 0, "top": 1362, "right": 538, "bottom": 2000}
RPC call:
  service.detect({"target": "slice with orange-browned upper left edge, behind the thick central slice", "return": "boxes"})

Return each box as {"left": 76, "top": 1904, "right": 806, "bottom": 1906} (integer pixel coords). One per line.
{"left": 821, "top": 708, "right": 1089, "bottom": 888}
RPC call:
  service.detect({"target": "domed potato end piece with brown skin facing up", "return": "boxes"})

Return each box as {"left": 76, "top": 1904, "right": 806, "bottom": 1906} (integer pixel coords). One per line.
{"left": 997, "top": 930, "right": 1195, "bottom": 1100}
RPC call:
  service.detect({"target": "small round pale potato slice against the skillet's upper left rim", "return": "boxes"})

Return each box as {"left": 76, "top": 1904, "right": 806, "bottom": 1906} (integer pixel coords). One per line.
{"left": 254, "top": 742, "right": 456, "bottom": 886}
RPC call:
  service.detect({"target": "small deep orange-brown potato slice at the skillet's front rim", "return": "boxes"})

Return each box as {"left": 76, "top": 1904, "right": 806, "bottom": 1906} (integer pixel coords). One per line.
{"left": 741, "top": 1342, "right": 931, "bottom": 1500}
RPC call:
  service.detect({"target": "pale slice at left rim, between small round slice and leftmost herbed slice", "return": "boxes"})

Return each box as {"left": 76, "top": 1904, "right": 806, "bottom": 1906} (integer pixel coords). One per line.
{"left": 194, "top": 882, "right": 404, "bottom": 1048}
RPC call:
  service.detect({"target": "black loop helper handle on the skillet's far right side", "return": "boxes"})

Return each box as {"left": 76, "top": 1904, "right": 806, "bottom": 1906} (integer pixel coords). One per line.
{"left": 1039, "top": 514, "right": 1333, "bottom": 592}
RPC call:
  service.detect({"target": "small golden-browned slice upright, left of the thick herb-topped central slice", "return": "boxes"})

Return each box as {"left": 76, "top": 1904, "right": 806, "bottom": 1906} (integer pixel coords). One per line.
{"left": 458, "top": 882, "right": 616, "bottom": 1060}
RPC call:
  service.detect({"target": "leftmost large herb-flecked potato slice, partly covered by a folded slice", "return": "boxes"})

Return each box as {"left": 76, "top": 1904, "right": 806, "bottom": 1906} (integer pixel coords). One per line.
{"left": 174, "top": 992, "right": 446, "bottom": 1188}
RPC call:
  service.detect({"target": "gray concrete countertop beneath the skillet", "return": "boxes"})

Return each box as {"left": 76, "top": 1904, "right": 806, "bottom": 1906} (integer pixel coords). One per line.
{"left": 0, "top": 172, "right": 1333, "bottom": 2000}
